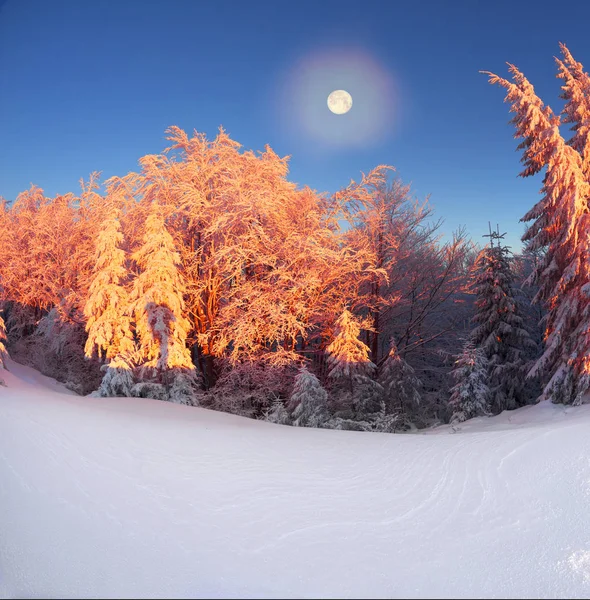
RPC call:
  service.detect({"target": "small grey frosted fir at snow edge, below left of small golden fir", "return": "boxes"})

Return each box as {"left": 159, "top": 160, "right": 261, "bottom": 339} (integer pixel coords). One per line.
{"left": 288, "top": 367, "right": 330, "bottom": 427}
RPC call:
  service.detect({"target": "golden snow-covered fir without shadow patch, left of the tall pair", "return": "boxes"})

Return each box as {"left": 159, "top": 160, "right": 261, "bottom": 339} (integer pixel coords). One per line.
{"left": 84, "top": 209, "right": 134, "bottom": 396}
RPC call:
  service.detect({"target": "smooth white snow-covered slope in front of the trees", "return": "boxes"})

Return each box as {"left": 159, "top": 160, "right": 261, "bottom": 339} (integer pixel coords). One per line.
{"left": 0, "top": 363, "right": 590, "bottom": 598}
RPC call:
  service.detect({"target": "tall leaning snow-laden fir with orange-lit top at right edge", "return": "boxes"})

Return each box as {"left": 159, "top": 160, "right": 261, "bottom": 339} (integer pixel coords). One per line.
{"left": 488, "top": 65, "right": 590, "bottom": 403}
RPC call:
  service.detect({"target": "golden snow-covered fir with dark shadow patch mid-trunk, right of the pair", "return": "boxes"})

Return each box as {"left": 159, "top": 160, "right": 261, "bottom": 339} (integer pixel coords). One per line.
{"left": 130, "top": 204, "right": 197, "bottom": 404}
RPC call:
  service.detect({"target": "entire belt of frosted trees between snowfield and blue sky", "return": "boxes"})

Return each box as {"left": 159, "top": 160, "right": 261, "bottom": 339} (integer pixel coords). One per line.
{"left": 0, "top": 45, "right": 590, "bottom": 432}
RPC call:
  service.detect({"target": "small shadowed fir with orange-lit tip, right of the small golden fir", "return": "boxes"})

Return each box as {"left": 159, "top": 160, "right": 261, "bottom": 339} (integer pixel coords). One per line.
{"left": 379, "top": 338, "right": 422, "bottom": 420}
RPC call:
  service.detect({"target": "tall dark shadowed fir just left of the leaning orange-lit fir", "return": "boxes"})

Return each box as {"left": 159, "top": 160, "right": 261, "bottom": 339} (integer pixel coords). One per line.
{"left": 471, "top": 231, "right": 535, "bottom": 413}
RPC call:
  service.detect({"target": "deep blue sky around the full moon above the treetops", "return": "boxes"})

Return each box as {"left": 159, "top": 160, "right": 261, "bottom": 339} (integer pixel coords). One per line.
{"left": 0, "top": 0, "right": 590, "bottom": 248}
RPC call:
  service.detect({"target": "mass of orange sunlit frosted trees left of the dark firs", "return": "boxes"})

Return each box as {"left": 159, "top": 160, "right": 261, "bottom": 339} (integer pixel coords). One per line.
{"left": 0, "top": 127, "right": 467, "bottom": 414}
